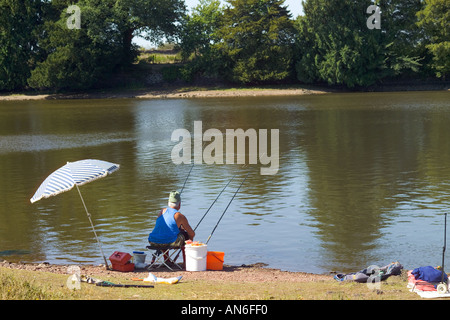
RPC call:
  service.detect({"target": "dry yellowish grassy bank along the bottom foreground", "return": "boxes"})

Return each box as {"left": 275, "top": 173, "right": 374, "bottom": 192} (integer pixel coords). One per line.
{"left": 0, "top": 267, "right": 420, "bottom": 300}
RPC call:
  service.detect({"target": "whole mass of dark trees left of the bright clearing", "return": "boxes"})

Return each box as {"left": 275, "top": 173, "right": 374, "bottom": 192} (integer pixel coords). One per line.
{"left": 0, "top": 0, "right": 185, "bottom": 90}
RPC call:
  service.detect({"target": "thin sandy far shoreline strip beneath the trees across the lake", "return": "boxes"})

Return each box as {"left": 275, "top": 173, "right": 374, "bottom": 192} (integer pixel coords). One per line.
{"left": 0, "top": 83, "right": 450, "bottom": 101}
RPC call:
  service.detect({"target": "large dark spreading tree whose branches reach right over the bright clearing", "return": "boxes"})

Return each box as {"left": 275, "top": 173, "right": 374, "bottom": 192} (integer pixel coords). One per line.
{"left": 28, "top": 0, "right": 184, "bottom": 89}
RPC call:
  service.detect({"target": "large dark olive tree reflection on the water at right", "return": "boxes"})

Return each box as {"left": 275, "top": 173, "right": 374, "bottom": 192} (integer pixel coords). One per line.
{"left": 300, "top": 95, "right": 450, "bottom": 270}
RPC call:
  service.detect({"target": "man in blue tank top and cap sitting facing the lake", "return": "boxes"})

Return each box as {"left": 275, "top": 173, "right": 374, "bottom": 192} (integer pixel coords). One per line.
{"left": 148, "top": 191, "right": 195, "bottom": 263}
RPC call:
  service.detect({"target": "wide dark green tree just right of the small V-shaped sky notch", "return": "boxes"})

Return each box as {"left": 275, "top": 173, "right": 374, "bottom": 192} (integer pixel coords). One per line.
{"left": 296, "top": 0, "right": 426, "bottom": 87}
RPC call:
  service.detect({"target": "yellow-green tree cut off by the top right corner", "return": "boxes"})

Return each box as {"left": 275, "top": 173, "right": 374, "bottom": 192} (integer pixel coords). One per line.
{"left": 417, "top": 0, "right": 450, "bottom": 78}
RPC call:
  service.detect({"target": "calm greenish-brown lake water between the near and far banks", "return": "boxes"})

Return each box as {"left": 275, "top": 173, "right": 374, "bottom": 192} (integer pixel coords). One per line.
{"left": 0, "top": 92, "right": 450, "bottom": 273}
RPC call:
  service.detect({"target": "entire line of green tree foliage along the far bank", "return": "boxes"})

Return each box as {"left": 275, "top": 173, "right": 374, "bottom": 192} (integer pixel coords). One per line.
{"left": 0, "top": 0, "right": 450, "bottom": 91}
